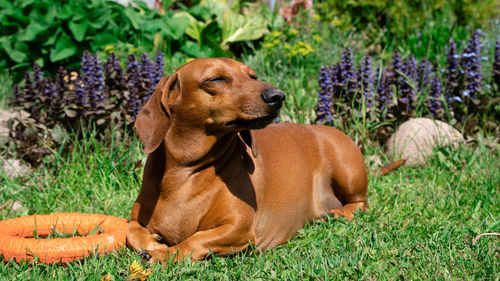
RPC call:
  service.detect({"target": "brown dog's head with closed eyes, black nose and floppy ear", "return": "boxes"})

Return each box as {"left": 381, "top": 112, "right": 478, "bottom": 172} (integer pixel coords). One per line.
{"left": 135, "top": 58, "right": 285, "bottom": 153}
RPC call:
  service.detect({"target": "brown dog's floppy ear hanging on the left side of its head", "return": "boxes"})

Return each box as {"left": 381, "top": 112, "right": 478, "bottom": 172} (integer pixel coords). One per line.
{"left": 134, "top": 73, "right": 177, "bottom": 153}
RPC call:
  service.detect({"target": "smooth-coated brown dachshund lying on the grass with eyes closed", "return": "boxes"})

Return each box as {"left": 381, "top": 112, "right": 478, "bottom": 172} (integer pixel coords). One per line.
{"left": 127, "top": 58, "right": 368, "bottom": 262}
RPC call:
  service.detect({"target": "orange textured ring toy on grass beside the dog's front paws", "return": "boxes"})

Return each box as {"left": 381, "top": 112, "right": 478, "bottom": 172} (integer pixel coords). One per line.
{"left": 0, "top": 213, "right": 127, "bottom": 264}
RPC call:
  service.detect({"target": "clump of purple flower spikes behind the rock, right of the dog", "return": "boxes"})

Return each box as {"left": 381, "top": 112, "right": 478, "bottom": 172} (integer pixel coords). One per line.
{"left": 317, "top": 30, "right": 500, "bottom": 142}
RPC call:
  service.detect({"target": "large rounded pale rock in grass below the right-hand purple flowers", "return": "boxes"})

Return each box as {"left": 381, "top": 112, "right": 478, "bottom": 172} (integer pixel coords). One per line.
{"left": 386, "top": 118, "right": 464, "bottom": 166}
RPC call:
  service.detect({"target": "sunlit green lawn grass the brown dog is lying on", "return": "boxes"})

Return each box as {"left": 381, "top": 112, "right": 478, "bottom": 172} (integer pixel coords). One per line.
{"left": 0, "top": 129, "right": 500, "bottom": 280}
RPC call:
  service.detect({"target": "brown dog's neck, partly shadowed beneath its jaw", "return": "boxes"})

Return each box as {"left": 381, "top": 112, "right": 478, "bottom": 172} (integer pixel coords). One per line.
{"left": 164, "top": 126, "right": 238, "bottom": 170}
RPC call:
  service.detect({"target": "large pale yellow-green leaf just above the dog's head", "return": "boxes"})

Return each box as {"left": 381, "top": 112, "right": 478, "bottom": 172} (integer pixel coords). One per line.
{"left": 222, "top": 10, "right": 268, "bottom": 46}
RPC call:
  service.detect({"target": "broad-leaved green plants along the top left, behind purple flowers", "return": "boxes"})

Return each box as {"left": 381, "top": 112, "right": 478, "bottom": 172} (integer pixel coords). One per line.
{"left": 0, "top": 0, "right": 267, "bottom": 81}
